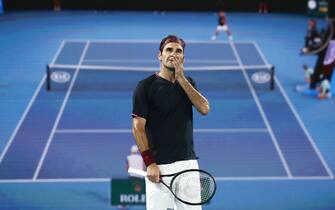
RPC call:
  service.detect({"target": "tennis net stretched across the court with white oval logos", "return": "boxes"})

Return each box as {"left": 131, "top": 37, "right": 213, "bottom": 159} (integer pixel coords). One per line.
{"left": 46, "top": 65, "right": 275, "bottom": 91}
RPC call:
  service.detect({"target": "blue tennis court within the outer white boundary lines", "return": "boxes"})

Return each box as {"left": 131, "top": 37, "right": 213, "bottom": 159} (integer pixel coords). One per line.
{"left": 0, "top": 40, "right": 333, "bottom": 182}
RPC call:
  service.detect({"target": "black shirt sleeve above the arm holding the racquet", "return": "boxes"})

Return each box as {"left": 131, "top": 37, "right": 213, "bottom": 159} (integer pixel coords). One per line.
{"left": 132, "top": 82, "right": 149, "bottom": 119}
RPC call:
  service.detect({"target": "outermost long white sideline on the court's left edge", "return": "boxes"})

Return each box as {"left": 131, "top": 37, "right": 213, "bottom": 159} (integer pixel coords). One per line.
{"left": 0, "top": 41, "right": 65, "bottom": 164}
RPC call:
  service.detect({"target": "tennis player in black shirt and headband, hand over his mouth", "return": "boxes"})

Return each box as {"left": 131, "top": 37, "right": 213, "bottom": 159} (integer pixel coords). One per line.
{"left": 132, "top": 35, "right": 210, "bottom": 210}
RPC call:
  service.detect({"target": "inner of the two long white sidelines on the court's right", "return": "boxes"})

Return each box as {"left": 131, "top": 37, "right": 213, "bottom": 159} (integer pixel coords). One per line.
{"left": 231, "top": 42, "right": 292, "bottom": 178}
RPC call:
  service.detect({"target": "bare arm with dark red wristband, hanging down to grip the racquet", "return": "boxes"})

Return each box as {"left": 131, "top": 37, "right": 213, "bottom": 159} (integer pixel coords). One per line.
{"left": 132, "top": 117, "right": 160, "bottom": 182}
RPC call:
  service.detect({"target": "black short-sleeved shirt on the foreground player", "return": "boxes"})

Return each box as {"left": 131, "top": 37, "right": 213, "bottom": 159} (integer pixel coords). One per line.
{"left": 133, "top": 74, "right": 196, "bottom": 164}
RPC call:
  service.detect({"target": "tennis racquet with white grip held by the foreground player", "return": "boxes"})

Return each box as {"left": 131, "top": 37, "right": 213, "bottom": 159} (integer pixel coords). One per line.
{"left": 128, "top": 168, "right": 216, "bottom": 205}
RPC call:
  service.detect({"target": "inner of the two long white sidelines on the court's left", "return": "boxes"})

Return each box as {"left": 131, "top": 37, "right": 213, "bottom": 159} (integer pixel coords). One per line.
{"left": 33, "top": 41, "right": 90, "bottom": 180}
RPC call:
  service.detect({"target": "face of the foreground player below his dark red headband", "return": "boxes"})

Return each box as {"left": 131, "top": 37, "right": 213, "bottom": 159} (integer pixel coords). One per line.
{"left": 158, "top": 42, "right": 184, "bottom": 70}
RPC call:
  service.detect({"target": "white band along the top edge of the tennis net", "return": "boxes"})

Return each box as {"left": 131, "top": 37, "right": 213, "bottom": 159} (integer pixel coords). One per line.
{"left": 49, "top": 64, "right": 272, "bottom": 72}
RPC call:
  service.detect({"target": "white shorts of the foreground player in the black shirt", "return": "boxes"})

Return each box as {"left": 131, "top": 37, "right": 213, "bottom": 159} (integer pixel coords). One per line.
{"left": 145, "top": 160, "right": 202, "bottom": 210}
